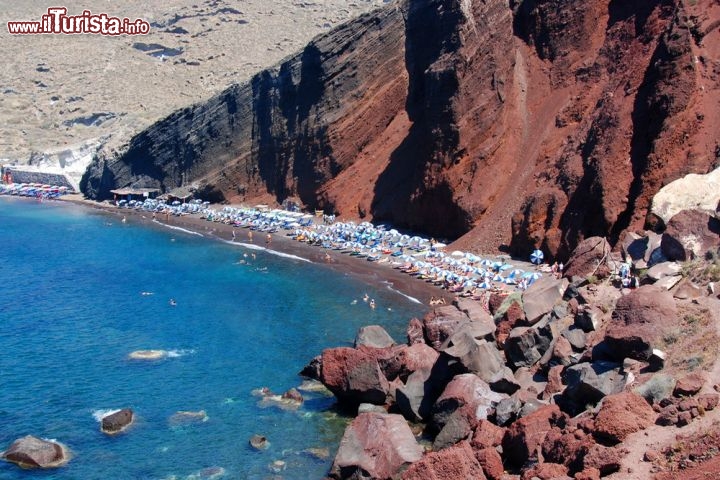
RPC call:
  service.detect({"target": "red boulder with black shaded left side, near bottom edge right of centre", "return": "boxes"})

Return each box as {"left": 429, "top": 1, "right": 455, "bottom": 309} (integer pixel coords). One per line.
{"left": 502, "top": 405, "right": 566, "bottom": 467}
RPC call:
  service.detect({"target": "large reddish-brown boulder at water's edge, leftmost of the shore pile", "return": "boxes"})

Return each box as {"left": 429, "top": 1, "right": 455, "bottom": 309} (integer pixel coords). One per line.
{"left": 320, "top": 347, "right": 390, "bottom": 405}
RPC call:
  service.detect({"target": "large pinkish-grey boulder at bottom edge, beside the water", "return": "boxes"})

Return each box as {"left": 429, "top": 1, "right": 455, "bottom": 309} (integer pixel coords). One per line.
{"left": 330, "top": 413, "right": 423, "bottom": 479}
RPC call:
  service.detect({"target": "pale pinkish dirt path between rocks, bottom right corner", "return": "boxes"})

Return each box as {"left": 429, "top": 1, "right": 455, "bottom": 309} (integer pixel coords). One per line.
{"left": 605, "top": 297, "right": 720, "bottom": 480}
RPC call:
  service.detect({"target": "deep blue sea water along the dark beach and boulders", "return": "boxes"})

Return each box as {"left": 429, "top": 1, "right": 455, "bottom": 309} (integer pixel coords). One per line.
{"left": 0, "top": 198, "right": 422, "bottom": 480}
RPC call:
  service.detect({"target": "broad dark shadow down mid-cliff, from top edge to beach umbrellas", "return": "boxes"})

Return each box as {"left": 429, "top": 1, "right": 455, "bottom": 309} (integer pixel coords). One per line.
{"left": 371, "top": 1, "right": 470, "bottom": 238}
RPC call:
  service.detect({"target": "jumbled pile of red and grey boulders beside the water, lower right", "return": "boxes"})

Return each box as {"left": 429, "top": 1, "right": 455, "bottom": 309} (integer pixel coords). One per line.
{"left": 303, "top": 232, "right": 720, "bottom": 480}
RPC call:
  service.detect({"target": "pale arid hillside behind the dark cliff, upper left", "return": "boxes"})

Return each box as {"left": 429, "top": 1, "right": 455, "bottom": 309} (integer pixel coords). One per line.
{"left": 0, "top": 0, "right": 384, "bottom": 161}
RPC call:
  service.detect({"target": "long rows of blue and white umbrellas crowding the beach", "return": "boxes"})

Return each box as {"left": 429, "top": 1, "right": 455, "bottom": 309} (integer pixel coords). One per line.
{"left": 95, "top": 194, "right": 544, "bottom": 304}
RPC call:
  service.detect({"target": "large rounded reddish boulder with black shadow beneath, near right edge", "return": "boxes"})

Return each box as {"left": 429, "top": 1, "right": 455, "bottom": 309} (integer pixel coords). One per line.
{"left": 605, "top": 286, "right": 678, "bottom": 360}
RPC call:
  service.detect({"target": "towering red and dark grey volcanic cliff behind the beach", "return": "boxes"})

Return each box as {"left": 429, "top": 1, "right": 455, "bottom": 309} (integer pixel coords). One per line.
{"left": 82, "top": 0, "right": 720, "bottom": 257}
